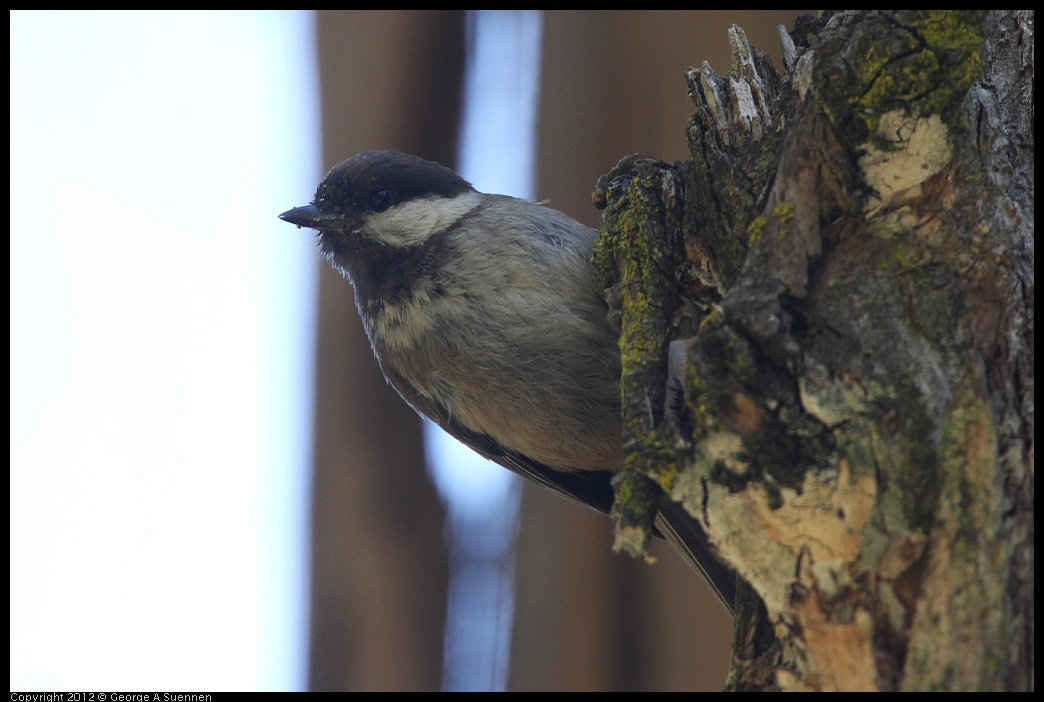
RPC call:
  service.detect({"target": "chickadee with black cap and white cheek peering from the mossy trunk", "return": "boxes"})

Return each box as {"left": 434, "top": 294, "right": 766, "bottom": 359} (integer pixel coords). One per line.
{"left": 279, "top": 151, "right": 735, "bottom": 608}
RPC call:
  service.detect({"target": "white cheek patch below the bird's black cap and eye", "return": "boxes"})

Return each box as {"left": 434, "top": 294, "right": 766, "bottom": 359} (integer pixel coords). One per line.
{"left": 363, "top": 190, "right": 481, "bottom": 248}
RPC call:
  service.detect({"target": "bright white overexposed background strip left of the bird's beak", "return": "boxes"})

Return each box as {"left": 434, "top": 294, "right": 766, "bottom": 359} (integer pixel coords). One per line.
{"left": 10, "top": 11, "right": 321, "bottom": 692}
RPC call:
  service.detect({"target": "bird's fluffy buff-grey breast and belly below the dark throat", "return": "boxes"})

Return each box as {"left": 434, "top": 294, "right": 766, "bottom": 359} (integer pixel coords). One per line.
{"left": 370, "top": 283, "right": 619, "bottom": 470}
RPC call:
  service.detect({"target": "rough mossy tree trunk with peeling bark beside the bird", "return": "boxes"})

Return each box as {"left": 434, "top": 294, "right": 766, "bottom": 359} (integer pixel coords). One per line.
{"left": 596, "top": 11, "right": 1034, "bottom": 691}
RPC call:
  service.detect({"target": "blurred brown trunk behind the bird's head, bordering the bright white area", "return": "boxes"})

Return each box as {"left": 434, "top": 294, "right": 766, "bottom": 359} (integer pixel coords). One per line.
{"left": 309, "top": 10, "right": 464, "bottom": 691}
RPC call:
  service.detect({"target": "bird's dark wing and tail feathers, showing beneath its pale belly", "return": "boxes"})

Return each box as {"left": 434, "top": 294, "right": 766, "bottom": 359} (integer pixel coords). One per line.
{"left": 385, "top": 372, "right": 736, "bottom": 612}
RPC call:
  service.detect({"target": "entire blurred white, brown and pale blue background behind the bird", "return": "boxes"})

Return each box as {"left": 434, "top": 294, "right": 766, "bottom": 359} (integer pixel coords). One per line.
{"left": 10, "top": 10, "right": 806, "bottom": 692}
